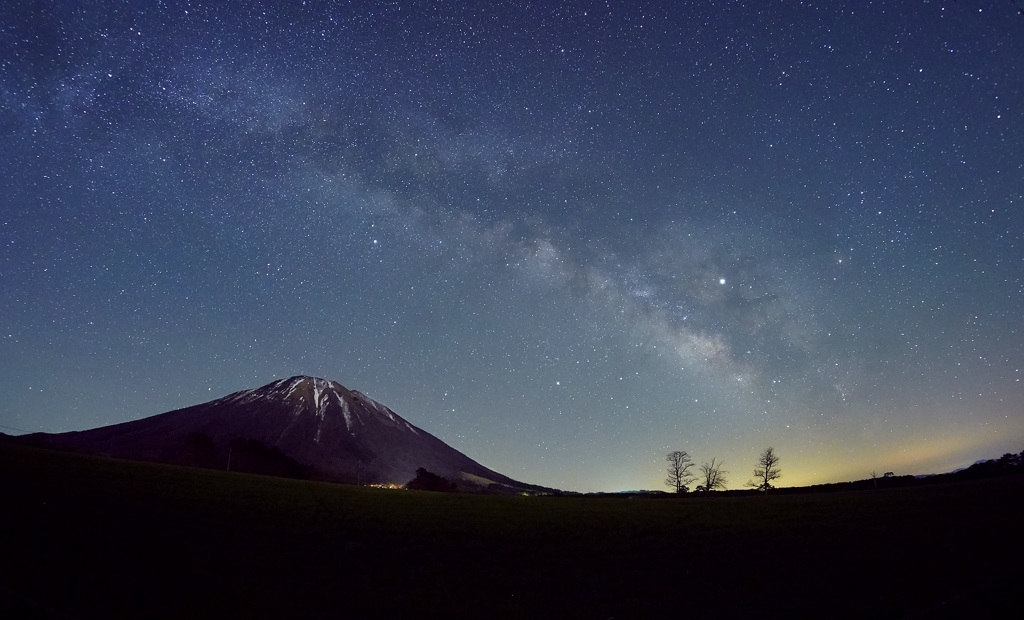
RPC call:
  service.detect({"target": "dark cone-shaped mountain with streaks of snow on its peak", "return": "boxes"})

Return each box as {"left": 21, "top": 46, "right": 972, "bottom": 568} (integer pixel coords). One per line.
{"left": 18, "top": 376, "right": 547, "bottom": 491}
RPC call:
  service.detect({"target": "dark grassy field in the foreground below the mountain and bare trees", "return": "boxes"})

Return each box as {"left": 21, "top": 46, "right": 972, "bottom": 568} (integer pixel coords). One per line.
{"left": 0, "top": 443, "right": 1024, "bottom": 618}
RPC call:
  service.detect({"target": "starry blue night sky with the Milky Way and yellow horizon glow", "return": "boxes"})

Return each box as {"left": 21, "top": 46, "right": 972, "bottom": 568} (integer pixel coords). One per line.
{"left": 0, "top": 0, "right": 1024, "bottom": 491}
